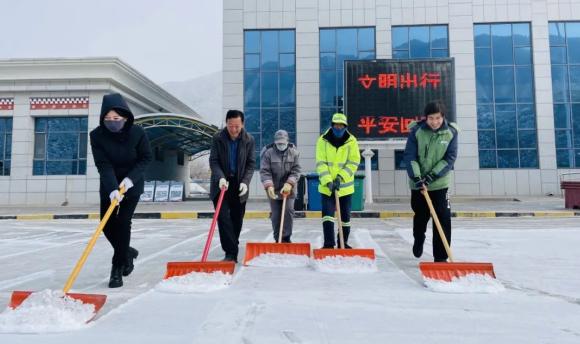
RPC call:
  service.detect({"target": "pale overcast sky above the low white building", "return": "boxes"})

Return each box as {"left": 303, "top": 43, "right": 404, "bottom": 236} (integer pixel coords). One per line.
{"left": 0, "top": 0, "right": 222, "bottom": 83}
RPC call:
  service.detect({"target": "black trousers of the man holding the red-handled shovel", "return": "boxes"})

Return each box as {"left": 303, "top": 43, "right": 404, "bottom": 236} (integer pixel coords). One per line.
{"left": 213, "top": 180, "right": 249, "bottom": 257}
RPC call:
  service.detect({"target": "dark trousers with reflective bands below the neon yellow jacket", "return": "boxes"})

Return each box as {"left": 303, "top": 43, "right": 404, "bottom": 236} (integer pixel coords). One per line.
{"left": 320, "top": 193, "right": 352, "bottom": 247}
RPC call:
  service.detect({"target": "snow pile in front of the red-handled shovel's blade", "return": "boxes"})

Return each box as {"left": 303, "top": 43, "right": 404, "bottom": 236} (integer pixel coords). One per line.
{"left": 155, "top": 271, "right": 233, "bottom": 293}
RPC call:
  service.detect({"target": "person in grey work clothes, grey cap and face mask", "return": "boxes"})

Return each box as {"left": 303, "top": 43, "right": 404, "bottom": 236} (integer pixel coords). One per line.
{"left": 260, "top": 130, "right": 301, "bottom": 243}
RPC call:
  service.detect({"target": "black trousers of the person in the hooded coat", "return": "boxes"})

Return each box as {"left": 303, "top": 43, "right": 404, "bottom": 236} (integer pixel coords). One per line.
{"left": 101, "top": 195, "right": 139, "bottom": 266}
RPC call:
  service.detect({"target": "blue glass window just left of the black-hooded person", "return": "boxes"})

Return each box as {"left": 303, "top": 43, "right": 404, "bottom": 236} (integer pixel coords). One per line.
{"left": 32, "top": 117, "right": 88, "bottom": 175}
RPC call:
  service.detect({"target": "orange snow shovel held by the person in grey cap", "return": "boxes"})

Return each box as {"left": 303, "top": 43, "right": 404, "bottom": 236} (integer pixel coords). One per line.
{"left": 244, "top": 194, "right": 310, "bottom": 265}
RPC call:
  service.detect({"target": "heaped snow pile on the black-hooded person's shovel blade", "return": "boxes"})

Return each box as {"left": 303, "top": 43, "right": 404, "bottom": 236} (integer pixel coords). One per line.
{"left": 0, "top": 289, "right": 95, "bottom": 333}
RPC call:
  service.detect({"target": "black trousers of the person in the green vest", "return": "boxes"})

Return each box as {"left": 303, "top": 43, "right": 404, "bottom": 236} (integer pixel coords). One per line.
{"left": 411, "top": 188, "right": 451, "bottom": 260}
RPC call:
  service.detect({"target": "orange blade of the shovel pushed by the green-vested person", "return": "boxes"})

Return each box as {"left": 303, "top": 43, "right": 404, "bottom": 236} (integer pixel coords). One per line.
{"left": 419, "top": 262, "right": 495, "bottom": 282}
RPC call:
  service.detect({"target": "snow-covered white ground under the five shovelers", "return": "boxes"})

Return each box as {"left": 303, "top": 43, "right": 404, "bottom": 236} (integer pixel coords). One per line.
{"left": 0, "top": 218, "right": 580, "bottom": 344}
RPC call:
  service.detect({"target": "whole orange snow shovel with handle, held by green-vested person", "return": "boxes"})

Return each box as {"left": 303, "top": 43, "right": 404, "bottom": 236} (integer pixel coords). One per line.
{"left": 419, "top": 188, "right": 495, "bottom": 282}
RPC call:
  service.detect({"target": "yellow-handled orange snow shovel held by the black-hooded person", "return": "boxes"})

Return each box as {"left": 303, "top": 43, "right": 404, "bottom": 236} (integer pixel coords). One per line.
{"left": 9, "top": 186, "right": 125, "bottom": 321}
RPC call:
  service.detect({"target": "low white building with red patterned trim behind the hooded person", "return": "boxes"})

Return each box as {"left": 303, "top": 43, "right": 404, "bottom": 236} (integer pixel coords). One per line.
{"left": 0, "top": 58, "right": 199, "bottom": 205}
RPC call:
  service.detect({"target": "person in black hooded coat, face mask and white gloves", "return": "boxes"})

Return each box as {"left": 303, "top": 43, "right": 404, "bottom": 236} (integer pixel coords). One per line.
{"left": 90, "top": 93, "right": 152, "bottom": 288}
